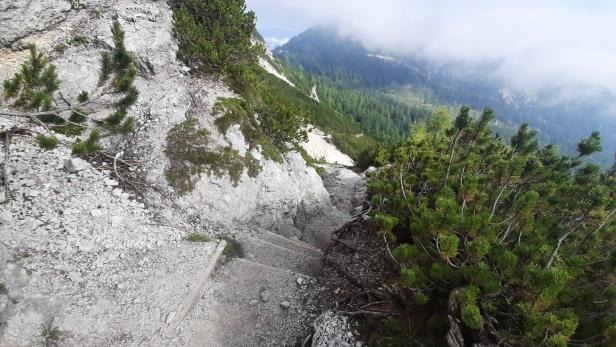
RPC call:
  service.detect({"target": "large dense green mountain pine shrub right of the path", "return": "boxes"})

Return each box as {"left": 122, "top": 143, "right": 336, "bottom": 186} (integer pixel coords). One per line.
{"left": 369, "top": 108, "right": 616, "bottom": 346}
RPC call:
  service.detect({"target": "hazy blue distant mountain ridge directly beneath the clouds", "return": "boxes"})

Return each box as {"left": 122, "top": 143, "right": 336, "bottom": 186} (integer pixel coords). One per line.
{"left": 274, "top": 27, "right": 616, "bottom": 166}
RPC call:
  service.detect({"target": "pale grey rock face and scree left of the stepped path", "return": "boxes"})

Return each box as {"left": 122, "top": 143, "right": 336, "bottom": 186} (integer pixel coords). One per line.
{"left": 0, "top": 0, "right": 356, "bottom": 346}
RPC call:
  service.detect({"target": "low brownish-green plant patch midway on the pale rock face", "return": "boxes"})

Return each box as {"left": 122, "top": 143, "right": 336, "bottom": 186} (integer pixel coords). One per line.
{"left": 165, "top": 118, "right": 261, "bottom": 193}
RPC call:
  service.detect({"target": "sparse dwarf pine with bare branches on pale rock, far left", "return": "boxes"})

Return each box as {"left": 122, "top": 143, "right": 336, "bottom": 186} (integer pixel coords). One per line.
{"left": 0, "top": 21, "right": 139, "bottom": 154}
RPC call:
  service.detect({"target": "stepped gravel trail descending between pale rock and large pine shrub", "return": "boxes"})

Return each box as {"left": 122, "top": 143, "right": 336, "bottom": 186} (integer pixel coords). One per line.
{"left": 185, "top": 166, "right": 366, "bottom": 346}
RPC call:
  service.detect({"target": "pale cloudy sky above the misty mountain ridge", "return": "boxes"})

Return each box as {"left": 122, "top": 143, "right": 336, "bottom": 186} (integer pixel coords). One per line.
{"left": 247, "top": 0, "right": 616, "bottom": 106}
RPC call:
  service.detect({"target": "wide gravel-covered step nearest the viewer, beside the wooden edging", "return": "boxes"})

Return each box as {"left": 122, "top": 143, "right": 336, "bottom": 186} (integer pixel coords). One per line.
{"left": 187, "top": 259, "right": 316, "bottom": 346}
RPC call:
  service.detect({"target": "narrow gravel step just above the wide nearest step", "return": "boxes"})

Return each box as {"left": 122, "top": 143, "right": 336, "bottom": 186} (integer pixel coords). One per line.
{"left": 238, "top": 236, "right": 323, "bottom": 276}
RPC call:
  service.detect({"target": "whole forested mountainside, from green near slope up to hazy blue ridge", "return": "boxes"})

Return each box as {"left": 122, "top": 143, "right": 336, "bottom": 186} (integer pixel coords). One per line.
{"left": 274, "top": 27, "right": 616, "bottom": 167}
